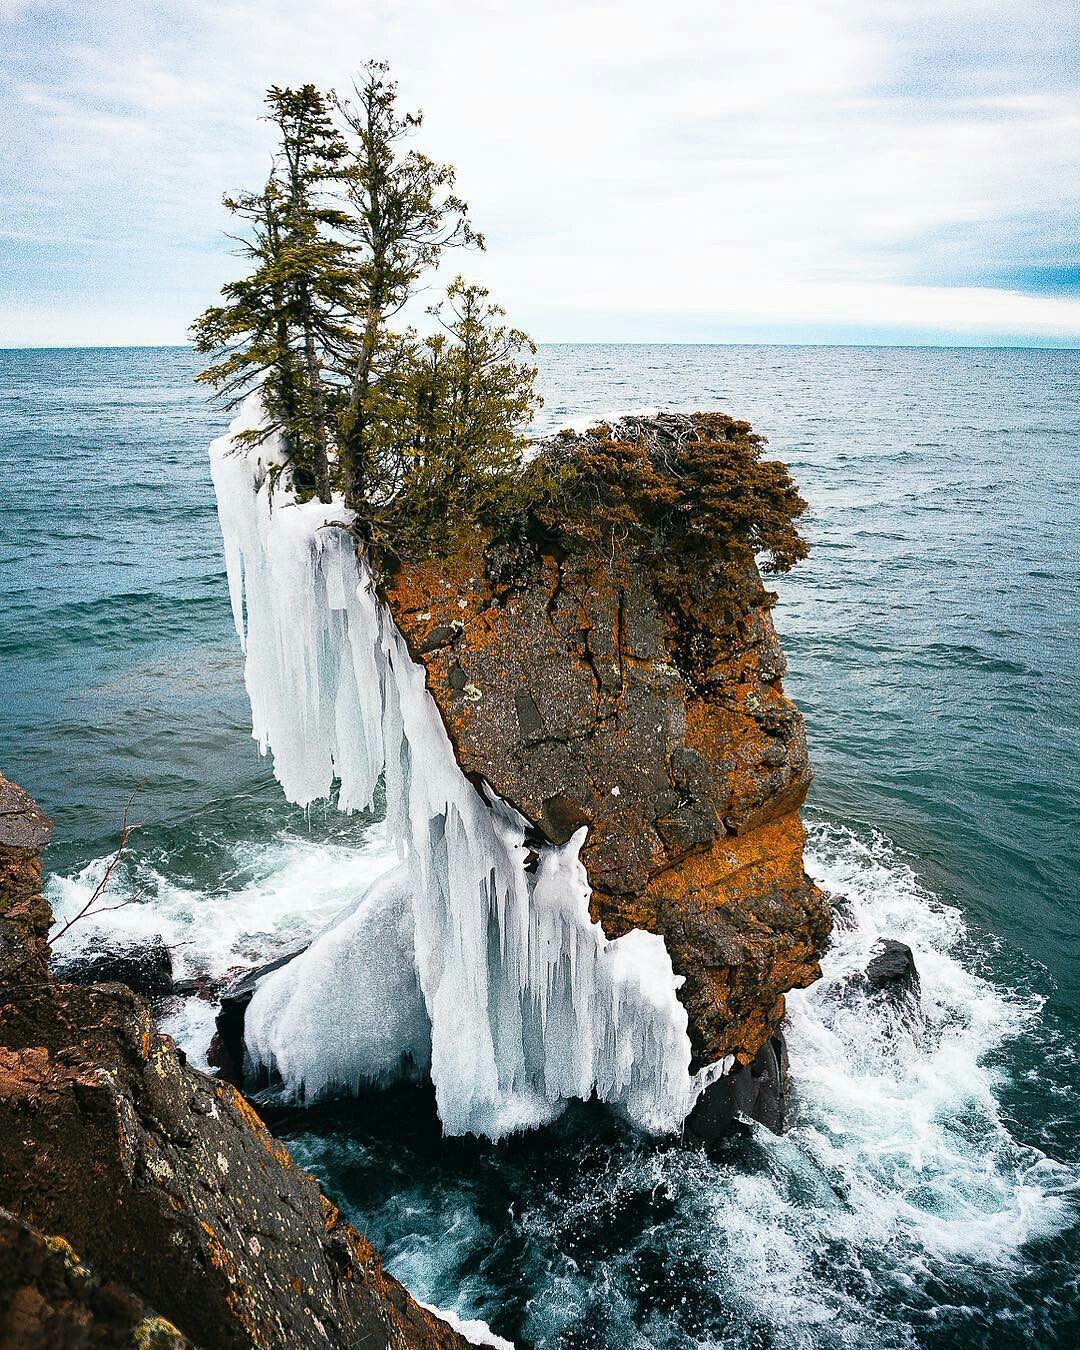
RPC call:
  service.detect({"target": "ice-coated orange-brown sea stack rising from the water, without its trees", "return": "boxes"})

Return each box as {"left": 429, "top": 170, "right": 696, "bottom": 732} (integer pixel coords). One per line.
{"left": 212, "top": 404, "right": 830, "bottom": 1138}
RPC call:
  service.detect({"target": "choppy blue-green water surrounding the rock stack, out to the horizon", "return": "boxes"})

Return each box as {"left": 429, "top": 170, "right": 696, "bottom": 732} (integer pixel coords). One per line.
{"left": 0, "top": 347, "right": 1080, "bottom": 1350}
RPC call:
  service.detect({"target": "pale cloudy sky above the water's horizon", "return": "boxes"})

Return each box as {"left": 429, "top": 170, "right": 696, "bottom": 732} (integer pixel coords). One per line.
{"left": 0, "top": 0, "right": 1080, "bottom": 347}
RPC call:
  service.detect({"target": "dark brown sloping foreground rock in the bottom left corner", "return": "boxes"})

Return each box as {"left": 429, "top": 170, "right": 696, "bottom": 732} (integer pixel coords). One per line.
{"left": 0, "top": 780, "right": 466, "bottom": 1350}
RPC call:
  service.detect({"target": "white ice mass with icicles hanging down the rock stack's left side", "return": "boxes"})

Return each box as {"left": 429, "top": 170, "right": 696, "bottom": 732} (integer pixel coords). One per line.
{"left": 211, "top": 404, "right": 729, "bottom": 1138}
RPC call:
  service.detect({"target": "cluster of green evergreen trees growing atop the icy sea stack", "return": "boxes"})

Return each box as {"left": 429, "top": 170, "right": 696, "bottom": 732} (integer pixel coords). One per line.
{"left": 193, "top": 62, "right": 539, "bottom": 556}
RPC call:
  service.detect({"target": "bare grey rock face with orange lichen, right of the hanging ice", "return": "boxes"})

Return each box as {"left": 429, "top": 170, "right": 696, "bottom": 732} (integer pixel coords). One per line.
{"left": 385, "top": 469, "right": 830, "bottom": 1064}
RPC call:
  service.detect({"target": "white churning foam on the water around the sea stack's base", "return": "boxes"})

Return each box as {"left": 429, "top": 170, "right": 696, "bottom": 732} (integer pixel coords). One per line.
{"left": 42, "top": 799, "right": 1080, "bottom": 1350}
